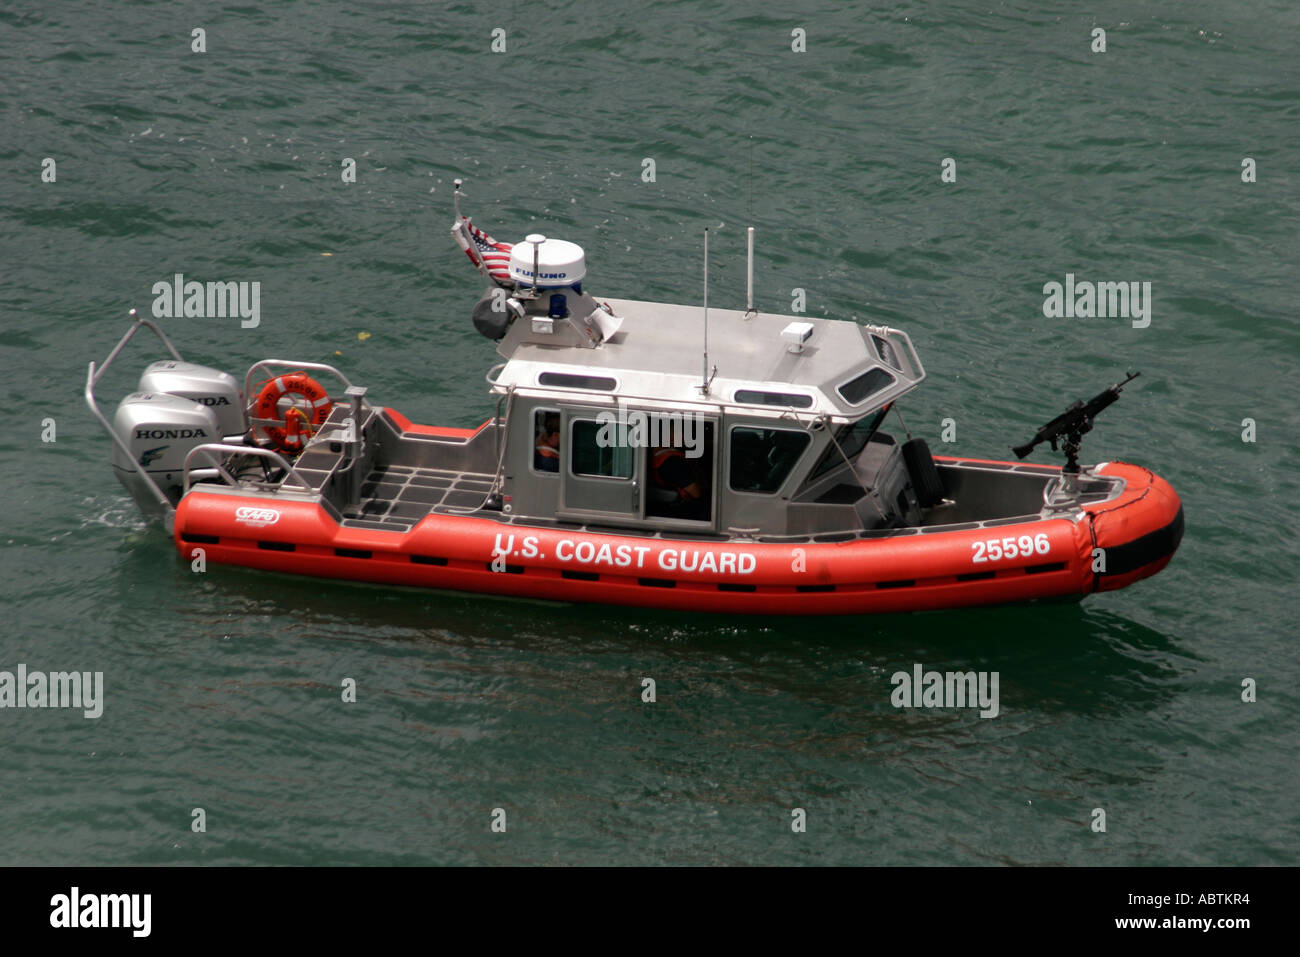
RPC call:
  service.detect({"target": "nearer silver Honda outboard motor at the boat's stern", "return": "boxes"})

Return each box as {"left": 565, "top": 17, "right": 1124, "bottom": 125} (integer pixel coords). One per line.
{"left": 113, "top": 393, "right": 221, "bottom": 515}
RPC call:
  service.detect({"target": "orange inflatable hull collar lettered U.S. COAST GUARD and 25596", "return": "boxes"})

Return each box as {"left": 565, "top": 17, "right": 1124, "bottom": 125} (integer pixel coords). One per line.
{"left": 174, "top": 459, "right": 1183, "bottom": 615}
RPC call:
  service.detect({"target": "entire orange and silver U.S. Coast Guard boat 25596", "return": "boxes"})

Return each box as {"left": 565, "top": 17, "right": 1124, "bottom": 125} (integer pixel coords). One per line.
{"left": 86, "top": 182, "right": 1183, "bottom": 615}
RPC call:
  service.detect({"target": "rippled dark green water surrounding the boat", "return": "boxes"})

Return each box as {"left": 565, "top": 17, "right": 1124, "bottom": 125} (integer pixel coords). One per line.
{"left": 0, "top": 0, "right": 1300, "bottom": 865}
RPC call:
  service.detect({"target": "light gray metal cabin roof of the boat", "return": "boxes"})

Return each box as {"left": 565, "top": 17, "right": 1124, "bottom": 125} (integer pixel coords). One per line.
{"left": 493, "top": 299, "right": 926, "bottom": 419}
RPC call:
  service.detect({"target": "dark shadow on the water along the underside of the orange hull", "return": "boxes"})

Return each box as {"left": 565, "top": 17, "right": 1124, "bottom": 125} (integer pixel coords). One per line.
{"left": 111, "top": 541, "right": 1191, "bottom": 714}
